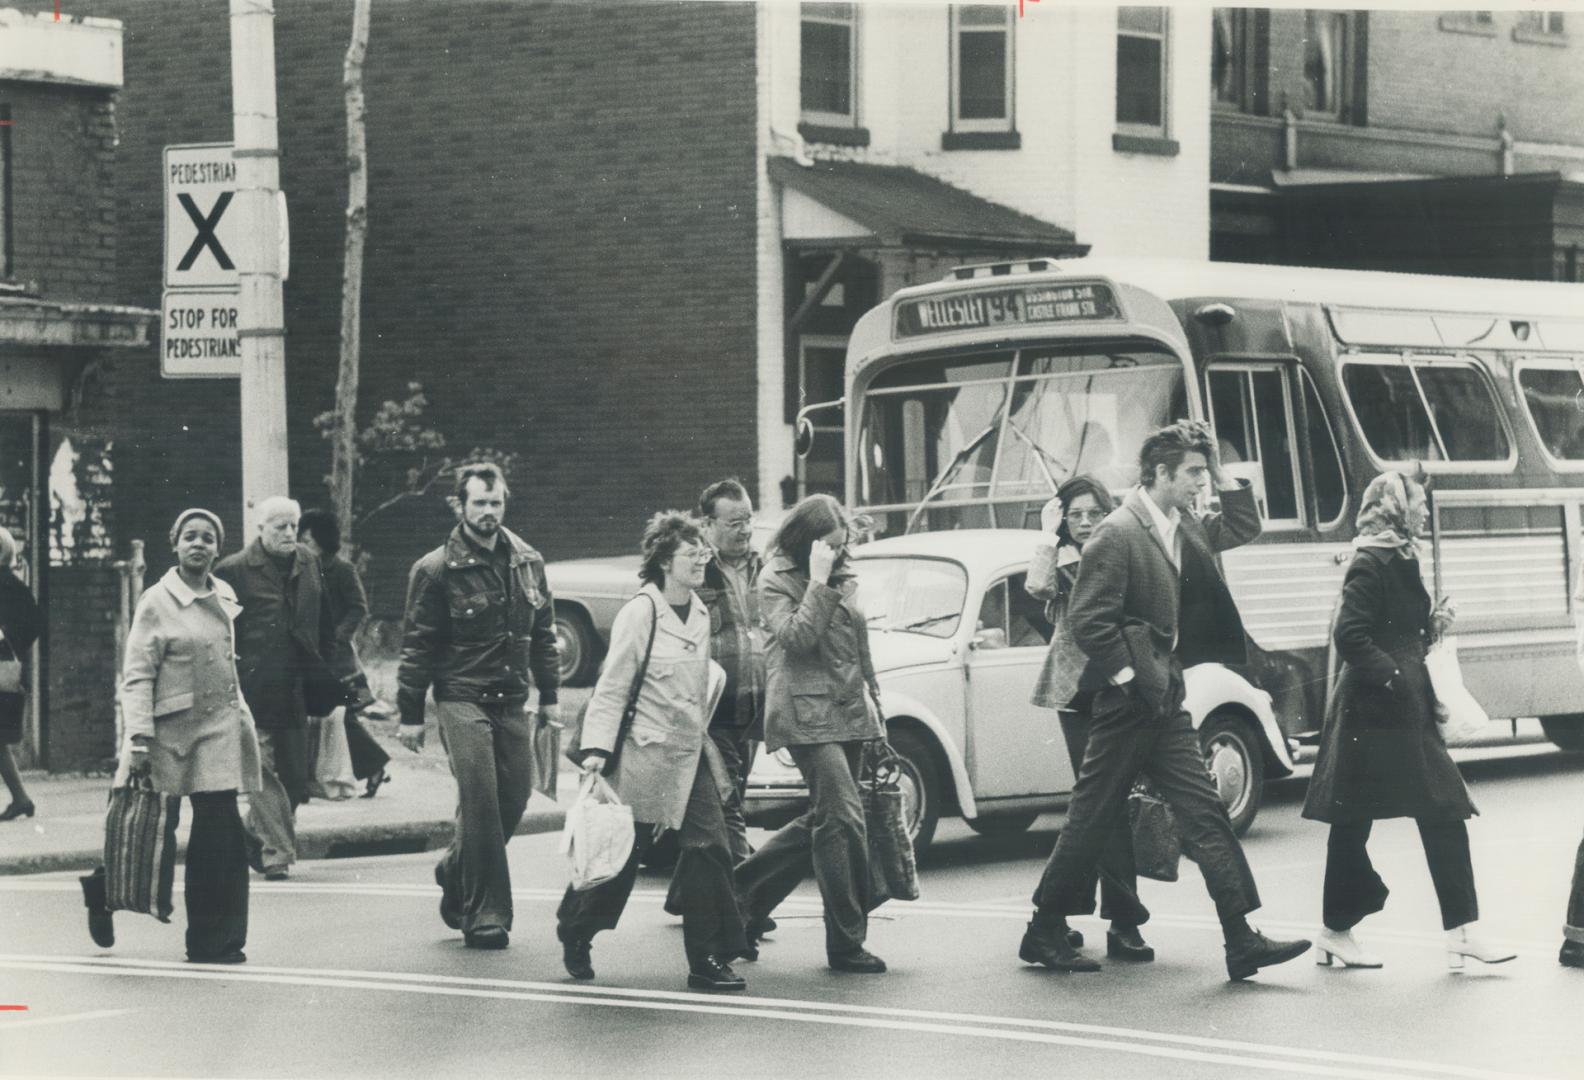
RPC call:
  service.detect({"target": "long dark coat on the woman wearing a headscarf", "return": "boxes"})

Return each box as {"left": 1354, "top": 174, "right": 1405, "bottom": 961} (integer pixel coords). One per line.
{"left": 1304, "top": 548, "right": 1478, "bottom": 823}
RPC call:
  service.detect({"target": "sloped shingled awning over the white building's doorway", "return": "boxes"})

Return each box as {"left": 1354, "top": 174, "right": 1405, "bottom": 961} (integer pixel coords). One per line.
{"left": 770, "top": 157, "right": 1090, "bottom": 255}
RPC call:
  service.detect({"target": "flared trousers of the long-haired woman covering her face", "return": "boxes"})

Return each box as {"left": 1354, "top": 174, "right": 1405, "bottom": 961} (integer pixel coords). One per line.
{"left": 737, "top": 743, "right": 868, "bottom": 956}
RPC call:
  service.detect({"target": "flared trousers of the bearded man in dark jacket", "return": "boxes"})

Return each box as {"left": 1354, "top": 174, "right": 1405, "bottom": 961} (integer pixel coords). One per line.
{"left": 434, "top": 702, "right": 534, "bottom": 934}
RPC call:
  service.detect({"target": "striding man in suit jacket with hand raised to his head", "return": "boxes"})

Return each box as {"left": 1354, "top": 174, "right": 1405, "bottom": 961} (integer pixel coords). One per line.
{"left": 1019, "top": 421, "right": 1310, "bottom": 979}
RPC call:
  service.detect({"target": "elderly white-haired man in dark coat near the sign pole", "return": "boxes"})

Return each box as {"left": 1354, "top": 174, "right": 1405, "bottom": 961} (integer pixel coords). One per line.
{"left": 214, "top": 496, "right": 323, "bottom": 880}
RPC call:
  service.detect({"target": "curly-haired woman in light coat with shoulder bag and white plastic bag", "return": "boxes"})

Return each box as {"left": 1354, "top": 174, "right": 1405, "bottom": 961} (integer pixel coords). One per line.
{"left": 556, "top": 510, "right": 748, "bottom": 990}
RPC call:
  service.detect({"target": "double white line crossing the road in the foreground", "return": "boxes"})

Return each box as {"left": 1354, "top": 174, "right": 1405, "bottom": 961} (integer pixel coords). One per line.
{"left": 0, "top": 953, "right": 1552, "bottom": 1080}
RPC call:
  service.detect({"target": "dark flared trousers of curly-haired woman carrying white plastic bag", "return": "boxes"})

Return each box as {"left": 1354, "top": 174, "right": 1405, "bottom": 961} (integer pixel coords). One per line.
{"left": 556, "top": 754, "right": 748, "bottom": 961}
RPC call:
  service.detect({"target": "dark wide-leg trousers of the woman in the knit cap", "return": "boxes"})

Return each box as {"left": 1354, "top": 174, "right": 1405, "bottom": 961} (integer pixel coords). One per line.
{"left": 184, "top": 792, "right": 247, "bottom": 960}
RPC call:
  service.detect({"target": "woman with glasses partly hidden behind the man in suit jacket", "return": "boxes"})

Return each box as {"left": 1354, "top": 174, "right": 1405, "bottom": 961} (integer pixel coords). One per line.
{"left": 1026, "top": 475, "right": 1155, "bottom": 961}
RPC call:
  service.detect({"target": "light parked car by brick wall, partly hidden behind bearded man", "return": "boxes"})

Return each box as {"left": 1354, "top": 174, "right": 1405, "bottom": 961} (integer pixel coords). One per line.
{"left": 545, "top": 516, "right": 779, "bottom": 686}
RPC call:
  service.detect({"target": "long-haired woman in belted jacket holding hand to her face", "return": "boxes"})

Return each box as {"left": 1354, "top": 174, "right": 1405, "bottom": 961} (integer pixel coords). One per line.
{"left": 737, "top": 496, "right": 885, "bottom": 974}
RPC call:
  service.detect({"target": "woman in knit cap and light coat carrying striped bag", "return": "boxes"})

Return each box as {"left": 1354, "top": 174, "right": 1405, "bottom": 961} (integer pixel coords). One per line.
{"left": 79, "top": 510, "right": 261, "bottom": 964}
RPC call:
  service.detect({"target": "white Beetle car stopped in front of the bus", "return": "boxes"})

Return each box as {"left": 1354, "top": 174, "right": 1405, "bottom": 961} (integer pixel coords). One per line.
{"left": 748, "top": 529, "right": 1293, "bottom": 852}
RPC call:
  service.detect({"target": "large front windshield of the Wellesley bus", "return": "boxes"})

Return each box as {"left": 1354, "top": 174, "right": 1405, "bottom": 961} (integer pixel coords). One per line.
{"left": 857, "top": 342, "right": 1188, "bottom": 534}
